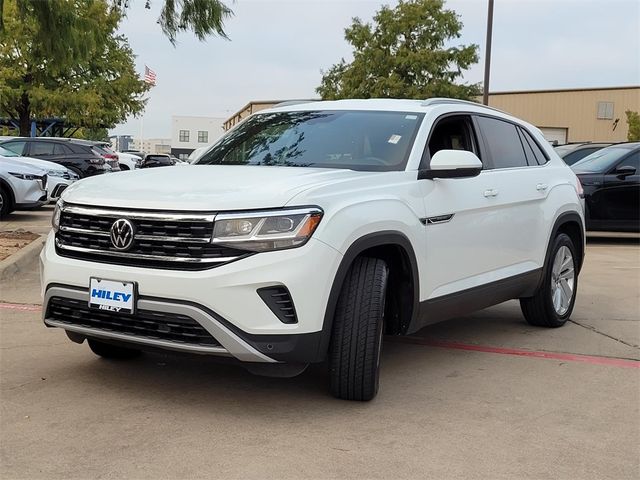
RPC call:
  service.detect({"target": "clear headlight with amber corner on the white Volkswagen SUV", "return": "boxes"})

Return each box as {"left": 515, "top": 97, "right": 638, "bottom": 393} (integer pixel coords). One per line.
{"left": 212, "top": 207, "right": 323, "bottom": 252}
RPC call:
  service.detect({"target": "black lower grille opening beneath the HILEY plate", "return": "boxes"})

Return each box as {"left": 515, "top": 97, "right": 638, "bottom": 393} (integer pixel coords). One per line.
{"left": 46, "top": 297, "right": 221, "bottom": 347}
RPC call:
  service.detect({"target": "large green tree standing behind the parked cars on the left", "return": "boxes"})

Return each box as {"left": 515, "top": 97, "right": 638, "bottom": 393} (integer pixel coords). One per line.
{"left": 0, "top": 0, "right": 149, "bottom": 136}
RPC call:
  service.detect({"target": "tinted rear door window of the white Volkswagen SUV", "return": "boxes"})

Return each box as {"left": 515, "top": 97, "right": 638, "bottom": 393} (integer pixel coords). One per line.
{"left": 477, "top": 117, "right": 528, "bottom": 169}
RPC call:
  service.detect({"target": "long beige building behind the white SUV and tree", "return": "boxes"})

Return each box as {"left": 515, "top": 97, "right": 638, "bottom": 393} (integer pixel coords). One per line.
{"left": 223, "top": 86, "right": 640, "bottom": 144}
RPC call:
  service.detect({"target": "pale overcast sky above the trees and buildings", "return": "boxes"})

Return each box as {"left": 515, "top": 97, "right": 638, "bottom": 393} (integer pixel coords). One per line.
{"left": 111, "top": 0, "right": 640, "bottom": 138}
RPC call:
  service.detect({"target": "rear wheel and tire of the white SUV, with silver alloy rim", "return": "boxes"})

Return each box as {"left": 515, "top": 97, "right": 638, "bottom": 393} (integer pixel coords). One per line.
{"left": 520, "top": 233, "right": 578, "bottom": 327}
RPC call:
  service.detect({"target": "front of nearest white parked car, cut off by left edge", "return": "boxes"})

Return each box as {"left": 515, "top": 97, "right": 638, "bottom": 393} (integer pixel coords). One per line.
{"left": 0, "top": 158, "right": 47, "bottom": 218}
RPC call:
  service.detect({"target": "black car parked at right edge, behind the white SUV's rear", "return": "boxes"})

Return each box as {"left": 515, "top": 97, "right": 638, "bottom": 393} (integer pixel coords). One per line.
{"left": 571, "top": 142, "right": 640, "bottom": 232}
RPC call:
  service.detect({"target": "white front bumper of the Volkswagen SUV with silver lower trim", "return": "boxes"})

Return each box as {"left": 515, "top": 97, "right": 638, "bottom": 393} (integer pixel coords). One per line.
{"left": 41, "top": 234, "right": 342, "bottom": 363}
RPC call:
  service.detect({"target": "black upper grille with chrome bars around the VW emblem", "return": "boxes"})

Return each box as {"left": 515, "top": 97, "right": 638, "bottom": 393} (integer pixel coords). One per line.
{"left": 56, "top": 205, "right": 249, "bottom": 270}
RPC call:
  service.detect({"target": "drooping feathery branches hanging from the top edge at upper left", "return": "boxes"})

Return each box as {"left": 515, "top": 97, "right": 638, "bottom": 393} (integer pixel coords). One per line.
{"left": 0, "top": 0, "right": 233, "bottom": 46}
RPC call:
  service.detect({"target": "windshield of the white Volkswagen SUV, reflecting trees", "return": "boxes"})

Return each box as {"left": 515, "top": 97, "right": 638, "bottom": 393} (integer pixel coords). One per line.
{"left": 195, "top": 111, "right": 423, "bottom": 171}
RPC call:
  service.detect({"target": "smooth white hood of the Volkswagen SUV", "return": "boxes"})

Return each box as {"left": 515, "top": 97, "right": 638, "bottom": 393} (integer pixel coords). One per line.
{"left": 62, "top": 165, "right": 370, "bottom": 211}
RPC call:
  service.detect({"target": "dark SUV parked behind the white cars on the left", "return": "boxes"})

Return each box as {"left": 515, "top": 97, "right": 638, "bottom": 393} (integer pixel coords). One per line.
{"left": 0, "top": 137, "right": 120, "bottom": 178}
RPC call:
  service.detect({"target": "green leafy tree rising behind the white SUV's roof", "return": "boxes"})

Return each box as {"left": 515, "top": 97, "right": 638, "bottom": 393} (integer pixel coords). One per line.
{"left": 316, "top": 0, "right": 481, "bottom": 100}
